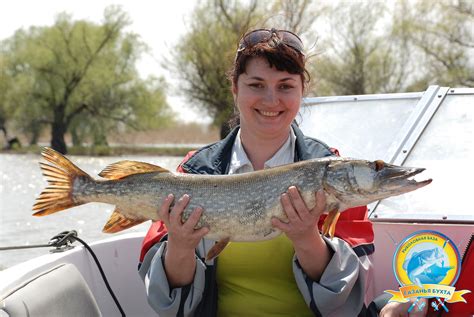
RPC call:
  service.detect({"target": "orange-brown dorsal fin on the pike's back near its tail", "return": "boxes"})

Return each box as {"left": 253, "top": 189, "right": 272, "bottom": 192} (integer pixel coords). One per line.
{"left": 99, "top": 161, "right": 169, "bottom": 179}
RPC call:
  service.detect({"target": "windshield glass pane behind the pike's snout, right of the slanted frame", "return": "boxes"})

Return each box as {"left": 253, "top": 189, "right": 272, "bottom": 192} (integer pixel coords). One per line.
{"left": 375, "top": 95, "right": 474, "bottom": 221}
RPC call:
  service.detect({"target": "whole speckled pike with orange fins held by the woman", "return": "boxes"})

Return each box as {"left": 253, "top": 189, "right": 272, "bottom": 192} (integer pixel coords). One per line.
{"left": 33, "top": 148, "right": 432, "bottom": 258}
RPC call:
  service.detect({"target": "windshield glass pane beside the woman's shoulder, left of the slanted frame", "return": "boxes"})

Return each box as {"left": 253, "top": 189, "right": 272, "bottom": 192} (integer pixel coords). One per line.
{"left": 297, "top": 95, "right": 420, "bottom": 161}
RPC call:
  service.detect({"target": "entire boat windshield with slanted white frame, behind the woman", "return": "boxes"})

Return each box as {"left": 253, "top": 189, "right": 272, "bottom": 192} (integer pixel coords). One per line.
{"left": 299, "top": 86, "right": 474, "bottom": 222}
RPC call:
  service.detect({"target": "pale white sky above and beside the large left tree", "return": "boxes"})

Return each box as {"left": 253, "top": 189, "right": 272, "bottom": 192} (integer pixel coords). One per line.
{"left": 0, "top": 0, "right": 210, "bottom": 123}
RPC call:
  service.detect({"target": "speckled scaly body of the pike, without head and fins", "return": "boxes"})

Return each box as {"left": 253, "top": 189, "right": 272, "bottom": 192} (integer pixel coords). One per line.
{"left": 73, "top": 162, "right": 327, "bottom": 241}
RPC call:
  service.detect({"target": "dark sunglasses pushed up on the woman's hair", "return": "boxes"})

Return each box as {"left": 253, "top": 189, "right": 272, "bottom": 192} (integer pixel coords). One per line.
{"left": 237, "top": 28, "right": 303, "bottom": 54}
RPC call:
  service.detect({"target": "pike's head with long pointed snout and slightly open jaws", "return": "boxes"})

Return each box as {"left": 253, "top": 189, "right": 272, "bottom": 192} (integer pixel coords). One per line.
{"left": 324, "top": 159, "right": 432, "bottom": 210}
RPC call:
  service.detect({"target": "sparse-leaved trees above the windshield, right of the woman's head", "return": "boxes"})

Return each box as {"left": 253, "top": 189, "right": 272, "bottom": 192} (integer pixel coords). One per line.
{"left": 311, "top": 0, "right": 474, "bottom": 95}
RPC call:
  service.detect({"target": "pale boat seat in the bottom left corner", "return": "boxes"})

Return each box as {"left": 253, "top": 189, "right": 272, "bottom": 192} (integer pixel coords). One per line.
{"left": 0, "top": 263, "right": 101, "bottom": 317}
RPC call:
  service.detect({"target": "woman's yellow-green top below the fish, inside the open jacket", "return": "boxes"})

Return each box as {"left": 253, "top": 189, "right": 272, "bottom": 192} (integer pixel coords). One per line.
{"left": 217, "top": 234, "right": 313, "bottom": 317}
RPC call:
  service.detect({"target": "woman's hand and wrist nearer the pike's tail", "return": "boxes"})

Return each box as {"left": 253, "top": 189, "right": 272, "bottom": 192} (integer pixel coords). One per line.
{"left": 158, "top": 194, "right": 209, "bottom": 288}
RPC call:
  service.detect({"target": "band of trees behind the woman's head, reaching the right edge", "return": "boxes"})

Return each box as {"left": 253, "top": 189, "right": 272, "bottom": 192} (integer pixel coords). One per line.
{"left": 167, "top": 0, "right": 474, "bottom": 136}
